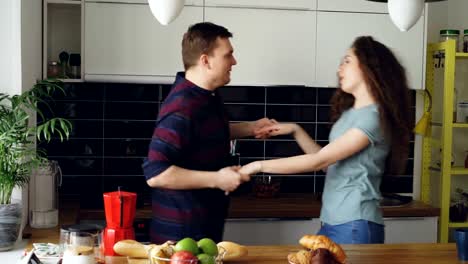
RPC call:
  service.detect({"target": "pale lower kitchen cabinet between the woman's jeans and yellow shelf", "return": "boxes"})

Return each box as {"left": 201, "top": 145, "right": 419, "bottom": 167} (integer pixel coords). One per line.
{"left": 384, "top": 217, "right": 438, "bottom": 244}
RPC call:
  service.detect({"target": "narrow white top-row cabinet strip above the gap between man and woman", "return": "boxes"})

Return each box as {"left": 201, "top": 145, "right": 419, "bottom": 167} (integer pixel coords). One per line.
{"left": 204, "top": 0, "right": 316, "bottom": 10}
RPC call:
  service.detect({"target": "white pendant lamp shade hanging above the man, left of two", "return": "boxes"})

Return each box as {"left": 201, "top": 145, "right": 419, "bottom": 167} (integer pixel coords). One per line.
{"left": 148, "top": 0, "right": 185, "bottom": 26}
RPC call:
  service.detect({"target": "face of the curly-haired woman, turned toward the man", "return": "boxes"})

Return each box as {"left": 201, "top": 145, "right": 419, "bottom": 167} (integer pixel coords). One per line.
{"left": 338, "top": 49, "right": 364, "bottom": 94}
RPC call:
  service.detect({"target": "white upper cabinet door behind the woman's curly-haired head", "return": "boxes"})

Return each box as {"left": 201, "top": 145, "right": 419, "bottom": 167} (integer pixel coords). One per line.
{"left": 316, "top": 12, "right": 424, "bottom": 89}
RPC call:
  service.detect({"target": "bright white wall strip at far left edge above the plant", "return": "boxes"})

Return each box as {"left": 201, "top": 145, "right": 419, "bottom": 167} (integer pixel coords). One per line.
{"left": 0, "top": 0, "right": 21, "bottom": 94}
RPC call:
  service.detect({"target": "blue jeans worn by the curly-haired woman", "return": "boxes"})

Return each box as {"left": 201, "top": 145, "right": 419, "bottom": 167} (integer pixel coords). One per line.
{"left": 317, "top": 220, "right": 385, "bottom": 244}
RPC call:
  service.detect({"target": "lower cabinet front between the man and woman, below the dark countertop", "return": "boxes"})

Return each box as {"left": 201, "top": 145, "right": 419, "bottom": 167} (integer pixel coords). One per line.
{"left": 223, "top": 218, "right": 320, "bottom": 245}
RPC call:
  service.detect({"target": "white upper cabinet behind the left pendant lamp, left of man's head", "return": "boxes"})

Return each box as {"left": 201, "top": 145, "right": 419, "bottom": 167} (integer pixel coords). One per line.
{"left": 85, "top": 3, "right": 203, "bottom": 83}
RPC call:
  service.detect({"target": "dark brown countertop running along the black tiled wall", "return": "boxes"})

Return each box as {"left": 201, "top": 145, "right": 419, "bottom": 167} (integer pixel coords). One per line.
{"left": 78, "top": 194, "right": 440, "bottom": 220}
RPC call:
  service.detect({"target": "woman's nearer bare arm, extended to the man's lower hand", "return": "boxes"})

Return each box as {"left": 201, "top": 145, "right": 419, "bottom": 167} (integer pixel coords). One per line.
{"left": 239, "top": 128, "right": 370, "bottom": 175}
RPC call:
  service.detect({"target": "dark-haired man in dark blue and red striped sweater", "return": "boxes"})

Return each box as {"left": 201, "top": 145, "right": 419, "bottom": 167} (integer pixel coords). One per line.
{"left": 143, "top": 22, "right": 272, "bottom": 243}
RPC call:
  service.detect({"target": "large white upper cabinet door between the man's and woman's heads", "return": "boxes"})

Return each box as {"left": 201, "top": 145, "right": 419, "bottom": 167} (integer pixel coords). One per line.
{"left": 205, "top": 7, "right": 316, "bottom": 85}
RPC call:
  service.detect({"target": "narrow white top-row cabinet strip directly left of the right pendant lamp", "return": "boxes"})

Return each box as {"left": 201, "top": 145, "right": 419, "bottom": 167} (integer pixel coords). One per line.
{"left": 317, "top": 0, "right": 388, "bottom": 13}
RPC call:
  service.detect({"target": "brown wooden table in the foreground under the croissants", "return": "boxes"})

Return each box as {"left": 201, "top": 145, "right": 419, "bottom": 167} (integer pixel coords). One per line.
{"left": 227, "top": 243, "right": 460, "bottom": 264}
